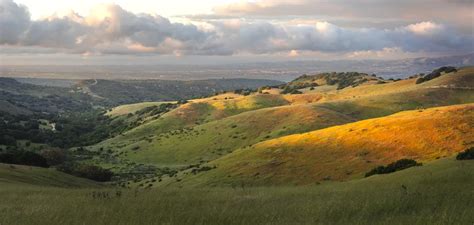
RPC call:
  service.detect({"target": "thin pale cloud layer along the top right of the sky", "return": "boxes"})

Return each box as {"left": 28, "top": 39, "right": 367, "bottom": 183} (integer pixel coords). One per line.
{"left": 214, "top": 0, "right": 474, "bottom": 33}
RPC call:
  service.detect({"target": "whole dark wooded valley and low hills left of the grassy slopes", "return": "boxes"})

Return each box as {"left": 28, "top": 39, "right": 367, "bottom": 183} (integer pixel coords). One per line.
{"left": 0, "top": 78, "right": 280, "bottom": 149}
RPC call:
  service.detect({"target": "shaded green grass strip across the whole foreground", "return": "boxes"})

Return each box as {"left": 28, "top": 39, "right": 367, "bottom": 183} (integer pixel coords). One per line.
{"left": 0, "top": 159, "right": 474, "bottom": 225}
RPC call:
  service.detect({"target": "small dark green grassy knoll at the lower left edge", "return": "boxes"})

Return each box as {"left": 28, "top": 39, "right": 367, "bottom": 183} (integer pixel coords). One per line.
{"left": 0, "top": 163, "right": 100, "bottom": 189}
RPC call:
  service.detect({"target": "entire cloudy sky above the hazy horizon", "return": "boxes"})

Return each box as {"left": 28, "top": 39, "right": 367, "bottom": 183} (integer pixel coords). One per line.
{"left": 0, "top": 0, "right": 474, "bottom": 64}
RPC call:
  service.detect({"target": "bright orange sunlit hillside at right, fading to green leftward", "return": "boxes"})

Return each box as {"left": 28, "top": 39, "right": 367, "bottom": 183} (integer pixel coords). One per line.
{"left": 182, "top": 104, "right": 474, "bottom": 184}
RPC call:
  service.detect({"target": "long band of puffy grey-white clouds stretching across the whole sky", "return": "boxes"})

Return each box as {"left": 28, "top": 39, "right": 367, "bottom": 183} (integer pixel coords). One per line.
{"left": 0, "top": 0, "right": 474, "bottom": 57}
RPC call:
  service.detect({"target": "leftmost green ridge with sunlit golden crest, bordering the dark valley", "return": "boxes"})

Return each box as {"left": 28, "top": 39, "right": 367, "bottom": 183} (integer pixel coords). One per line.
{"left": 93, "top": 94, "right": 287, "bottom": 163}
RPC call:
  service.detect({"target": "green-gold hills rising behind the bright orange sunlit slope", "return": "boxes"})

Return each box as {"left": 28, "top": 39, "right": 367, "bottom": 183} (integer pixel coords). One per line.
{"left": 90, "top": 68, "right": 474, "bottom": 172}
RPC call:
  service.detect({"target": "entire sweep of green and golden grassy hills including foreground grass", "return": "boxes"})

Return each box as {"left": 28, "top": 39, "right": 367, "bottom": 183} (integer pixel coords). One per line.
{"left": 0, "top": 67, "right": 474, "bottom": 225}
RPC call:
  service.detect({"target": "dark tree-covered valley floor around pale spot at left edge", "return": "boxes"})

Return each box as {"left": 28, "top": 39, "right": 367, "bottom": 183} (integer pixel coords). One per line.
{"left": 0, "top": 109, "right": 128, "bottom": 148}
